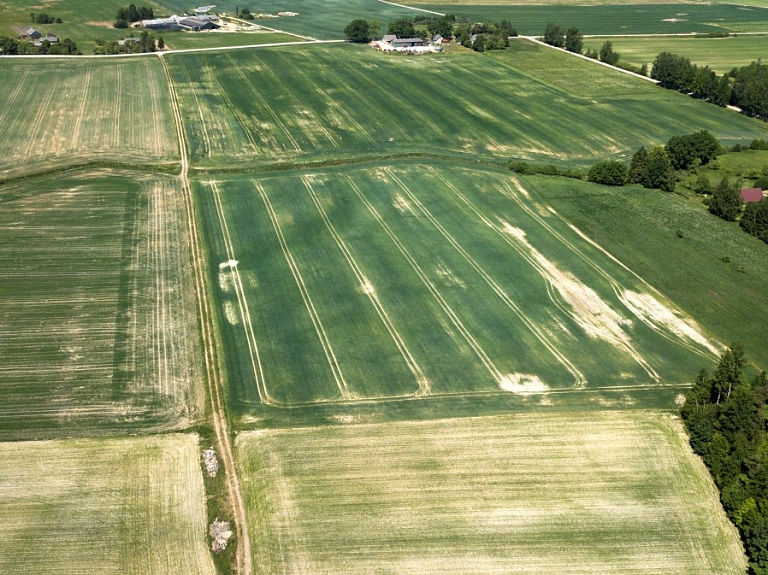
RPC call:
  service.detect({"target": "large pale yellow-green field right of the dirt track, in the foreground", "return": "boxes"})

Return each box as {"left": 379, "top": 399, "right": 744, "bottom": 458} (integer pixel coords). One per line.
{"left": 237, "top": 412, "right": 745, "bottom": 575}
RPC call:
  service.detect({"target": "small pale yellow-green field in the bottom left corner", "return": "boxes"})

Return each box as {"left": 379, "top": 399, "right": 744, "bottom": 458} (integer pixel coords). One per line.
{"left": 0, "top": 435, "right": 215, "bottom": 575}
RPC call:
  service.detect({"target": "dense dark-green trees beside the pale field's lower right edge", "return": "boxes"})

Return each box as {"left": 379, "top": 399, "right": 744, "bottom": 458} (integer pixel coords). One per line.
{"left": 681, "top": 344, "right": 768, "bottom": 575}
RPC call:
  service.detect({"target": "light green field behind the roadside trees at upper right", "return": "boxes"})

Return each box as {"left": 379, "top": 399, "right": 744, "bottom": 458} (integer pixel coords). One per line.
{"left": 584, "top": 35, "right": 768, "bottom": 74}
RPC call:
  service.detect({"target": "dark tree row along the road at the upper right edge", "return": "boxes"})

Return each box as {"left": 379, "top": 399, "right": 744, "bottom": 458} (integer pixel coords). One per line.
{"left": 651, "top": 52, "right": 768, "bottom": 120}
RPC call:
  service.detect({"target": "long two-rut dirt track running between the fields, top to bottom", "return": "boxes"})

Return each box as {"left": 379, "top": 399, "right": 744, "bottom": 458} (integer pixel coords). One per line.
{"left": 160, "top": 53, "right": 253, "bottom": 575}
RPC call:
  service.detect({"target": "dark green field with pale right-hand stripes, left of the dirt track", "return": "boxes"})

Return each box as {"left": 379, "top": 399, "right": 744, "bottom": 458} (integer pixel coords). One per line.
{"left": 0, "top": 172, "right": 205, "bottom": 439}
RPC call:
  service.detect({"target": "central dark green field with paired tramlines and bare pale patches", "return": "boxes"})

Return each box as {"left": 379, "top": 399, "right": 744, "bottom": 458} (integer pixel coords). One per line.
{"left": 197, "top": 163, "right": 719, "bottom": 414}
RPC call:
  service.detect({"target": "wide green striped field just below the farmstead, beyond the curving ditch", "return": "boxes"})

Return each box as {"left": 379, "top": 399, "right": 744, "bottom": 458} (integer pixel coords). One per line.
{"left": 169, "top": 40, "right": 768, "bottom": 169}
